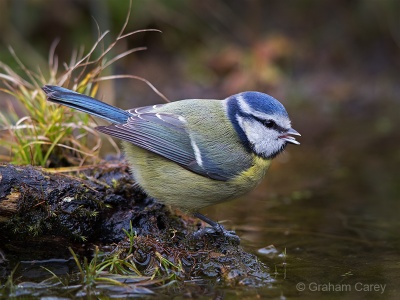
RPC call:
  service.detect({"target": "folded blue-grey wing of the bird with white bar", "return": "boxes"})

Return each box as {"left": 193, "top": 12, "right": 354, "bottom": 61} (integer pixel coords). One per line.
{"left": 96, "top": 106, "right": 237, "bottom": 181}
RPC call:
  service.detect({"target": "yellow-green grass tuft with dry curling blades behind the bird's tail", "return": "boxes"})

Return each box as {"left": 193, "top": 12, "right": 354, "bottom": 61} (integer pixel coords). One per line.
{"left": 0, "top": 5, "right": 167, "bottom": 167}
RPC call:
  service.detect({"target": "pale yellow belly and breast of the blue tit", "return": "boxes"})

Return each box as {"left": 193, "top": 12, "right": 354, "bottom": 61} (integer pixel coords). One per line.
{"left": 123, "top": 142, "right": 270, "bottom": 211}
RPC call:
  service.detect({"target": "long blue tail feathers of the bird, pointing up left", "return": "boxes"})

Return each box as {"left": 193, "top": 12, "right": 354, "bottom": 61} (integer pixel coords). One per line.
{"left": 42, "top": 85, "right": 131, "bottom": 123}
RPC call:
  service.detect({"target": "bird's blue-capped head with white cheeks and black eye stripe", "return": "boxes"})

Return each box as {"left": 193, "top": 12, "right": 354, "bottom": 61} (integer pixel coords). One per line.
{"left": 225, "top": 92, "right": 300, "bottom": 159}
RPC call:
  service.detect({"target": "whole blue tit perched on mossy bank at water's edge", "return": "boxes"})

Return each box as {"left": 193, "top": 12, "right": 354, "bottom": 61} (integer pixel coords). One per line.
{"left": 42, "top": 85, "right": 300, "bottom": 240}
